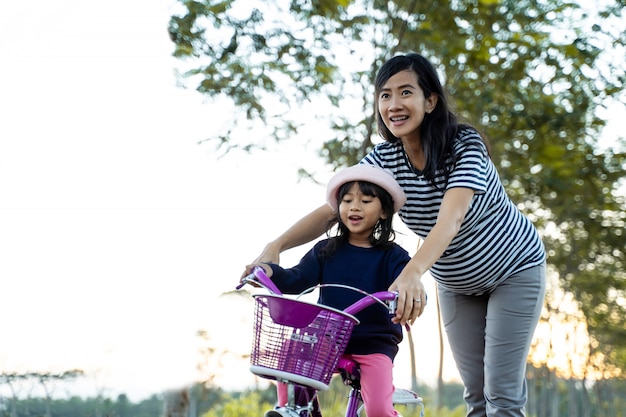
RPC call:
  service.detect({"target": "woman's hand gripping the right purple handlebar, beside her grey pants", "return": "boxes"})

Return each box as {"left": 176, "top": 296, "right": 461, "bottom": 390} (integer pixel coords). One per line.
{"left": 389, "top": 262, "right": 426, "bottom": 325}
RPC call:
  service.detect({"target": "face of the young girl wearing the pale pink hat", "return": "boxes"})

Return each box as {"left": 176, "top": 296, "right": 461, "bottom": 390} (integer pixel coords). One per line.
{"left": 339, "top": 182, "right": 387, "bottom": 247}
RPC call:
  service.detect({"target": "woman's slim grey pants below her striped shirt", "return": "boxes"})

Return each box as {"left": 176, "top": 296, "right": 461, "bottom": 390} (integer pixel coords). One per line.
{"left": 439, "top": 264, "right": 546, "bottom": 417}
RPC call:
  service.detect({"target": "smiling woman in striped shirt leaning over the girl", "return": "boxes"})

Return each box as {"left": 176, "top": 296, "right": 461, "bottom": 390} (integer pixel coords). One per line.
{"left": 247, "top": 54, "right": 545, "bottom": 417}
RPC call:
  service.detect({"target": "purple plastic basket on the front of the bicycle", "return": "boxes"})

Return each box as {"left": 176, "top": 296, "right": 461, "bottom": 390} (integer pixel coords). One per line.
{"left": 250, "top": 294, "right": 359, "bottom": 390}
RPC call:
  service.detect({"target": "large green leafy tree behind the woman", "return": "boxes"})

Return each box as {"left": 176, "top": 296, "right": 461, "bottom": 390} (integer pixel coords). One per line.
{"left": 169, "top": 0, "right": 626, "bottom": 369}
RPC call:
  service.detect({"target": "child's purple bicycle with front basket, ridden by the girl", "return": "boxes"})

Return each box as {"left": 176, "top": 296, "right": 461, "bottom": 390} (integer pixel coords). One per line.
{"left": 237, "top": 267, "right": 424, "bottom": 417}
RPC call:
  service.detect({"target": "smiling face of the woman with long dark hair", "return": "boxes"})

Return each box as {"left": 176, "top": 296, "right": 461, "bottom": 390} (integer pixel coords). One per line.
{"left": 377, "top": 70, "right": 437, "bottom": 142}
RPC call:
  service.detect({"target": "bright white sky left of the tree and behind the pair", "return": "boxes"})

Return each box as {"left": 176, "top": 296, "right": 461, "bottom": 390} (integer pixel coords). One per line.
{"left": 0, "top": 0, "right": 620, "bottom": 400}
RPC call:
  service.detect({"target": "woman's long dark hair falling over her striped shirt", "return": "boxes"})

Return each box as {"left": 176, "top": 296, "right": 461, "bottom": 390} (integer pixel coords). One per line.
{"left": 375, "top": 53, "right": 487, "bottom": 180}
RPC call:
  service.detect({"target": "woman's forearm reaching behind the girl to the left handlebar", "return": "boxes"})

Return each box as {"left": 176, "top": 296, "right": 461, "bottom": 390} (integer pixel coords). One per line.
{"left": 246, "top": 204, "right": 335, "bottom": 269}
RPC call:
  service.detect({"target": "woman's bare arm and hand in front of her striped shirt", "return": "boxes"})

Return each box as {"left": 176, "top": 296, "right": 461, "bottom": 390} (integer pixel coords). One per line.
{"left": 389, "top": 188, "right": 474, "bottom": 324}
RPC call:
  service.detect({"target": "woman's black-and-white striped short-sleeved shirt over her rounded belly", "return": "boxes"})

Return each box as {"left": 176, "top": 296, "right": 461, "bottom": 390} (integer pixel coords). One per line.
{"left": 361, "top": 129, "right": 546, "bottom": 295}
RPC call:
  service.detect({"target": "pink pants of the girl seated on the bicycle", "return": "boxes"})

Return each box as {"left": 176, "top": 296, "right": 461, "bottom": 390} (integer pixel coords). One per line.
{"left": 276, "top": 353, "right": 398, "bottom": 417}
